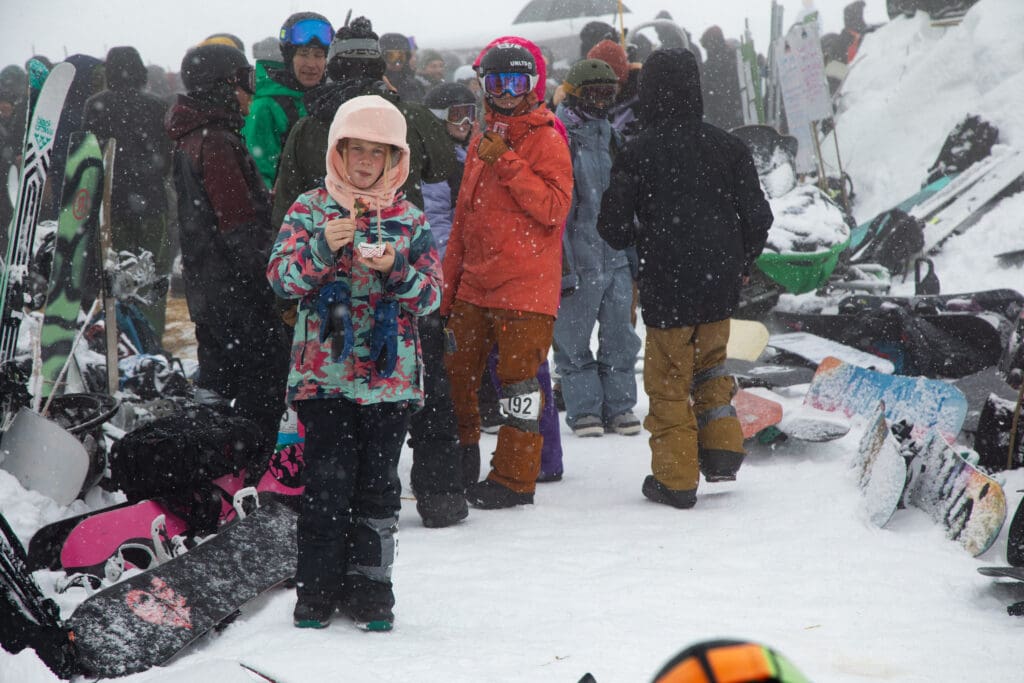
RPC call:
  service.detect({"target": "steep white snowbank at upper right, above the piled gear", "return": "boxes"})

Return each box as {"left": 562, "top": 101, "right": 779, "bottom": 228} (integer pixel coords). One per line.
{"left": 822, "top": 0, "right": 1024, "bottom": 222}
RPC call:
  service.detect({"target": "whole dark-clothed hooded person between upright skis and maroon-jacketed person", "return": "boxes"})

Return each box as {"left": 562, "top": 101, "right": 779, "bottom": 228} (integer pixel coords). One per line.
{"left": 84, "top": 47, "right": 172, "bottom": 339}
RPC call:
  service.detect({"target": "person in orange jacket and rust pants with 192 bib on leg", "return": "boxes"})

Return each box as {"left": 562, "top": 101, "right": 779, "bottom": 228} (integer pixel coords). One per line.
{"left": 441, "top": 43, "right": 572, "bottom": 509}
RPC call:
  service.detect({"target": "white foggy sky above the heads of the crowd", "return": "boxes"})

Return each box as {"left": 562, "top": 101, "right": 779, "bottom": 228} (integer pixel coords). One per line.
{"left": 0, "top": 0, "right": 887, "bottom": 71}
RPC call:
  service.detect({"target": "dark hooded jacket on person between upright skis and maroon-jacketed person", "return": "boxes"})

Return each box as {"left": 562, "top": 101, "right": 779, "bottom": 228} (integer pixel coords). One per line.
{"left": 84, "top": 47, "right": 171, "bottom": 216}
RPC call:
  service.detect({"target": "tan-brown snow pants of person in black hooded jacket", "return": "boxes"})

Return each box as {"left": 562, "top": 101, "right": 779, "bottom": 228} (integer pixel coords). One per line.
{"left": 643, "top": 319, "right": 743, "bottom": 490}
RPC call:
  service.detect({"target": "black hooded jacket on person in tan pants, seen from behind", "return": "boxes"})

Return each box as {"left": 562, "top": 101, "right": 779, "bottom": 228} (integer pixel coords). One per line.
{"left": 597, "top": 48, "right": 772, "bottom": 328}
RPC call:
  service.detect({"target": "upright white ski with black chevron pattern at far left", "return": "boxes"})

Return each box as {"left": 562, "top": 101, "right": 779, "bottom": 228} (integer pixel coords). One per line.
{"left": 0, "top": 62, "right": 75, "bottom": 364}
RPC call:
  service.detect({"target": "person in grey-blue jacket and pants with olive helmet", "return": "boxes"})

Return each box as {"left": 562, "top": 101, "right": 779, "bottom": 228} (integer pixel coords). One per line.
{"left": 555, "top": 59, "right": 640, "bottom": 436}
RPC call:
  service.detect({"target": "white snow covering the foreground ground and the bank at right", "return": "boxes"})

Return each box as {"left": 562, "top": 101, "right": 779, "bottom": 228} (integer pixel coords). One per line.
{"left": 6, "top": 0, "right": 1024, "bottom": 683}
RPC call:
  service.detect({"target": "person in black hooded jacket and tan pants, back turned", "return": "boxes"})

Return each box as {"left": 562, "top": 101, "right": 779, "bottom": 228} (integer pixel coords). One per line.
{"left": 597, "top": 48, "right": 772, "bottom": 508}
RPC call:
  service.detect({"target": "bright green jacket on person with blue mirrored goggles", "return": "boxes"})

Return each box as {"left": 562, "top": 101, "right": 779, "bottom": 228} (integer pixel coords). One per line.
{"left": 242, "top": 59, "right": 309, "bottom": 189}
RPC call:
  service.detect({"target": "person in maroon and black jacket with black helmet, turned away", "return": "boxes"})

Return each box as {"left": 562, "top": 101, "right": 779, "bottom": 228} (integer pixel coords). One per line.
{"left": 167, "top": 45, "right": 290, "bottom": 443}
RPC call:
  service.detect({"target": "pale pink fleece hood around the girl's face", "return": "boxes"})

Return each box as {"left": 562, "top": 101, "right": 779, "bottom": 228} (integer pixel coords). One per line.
{"left": 324, "top": 95, "right": 409, "bottom": 212}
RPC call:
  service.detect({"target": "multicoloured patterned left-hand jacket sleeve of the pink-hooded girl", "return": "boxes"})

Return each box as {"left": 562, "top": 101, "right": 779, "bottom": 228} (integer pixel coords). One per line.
{"left": 266, "top": 194, "right": 335, "bottom": 299}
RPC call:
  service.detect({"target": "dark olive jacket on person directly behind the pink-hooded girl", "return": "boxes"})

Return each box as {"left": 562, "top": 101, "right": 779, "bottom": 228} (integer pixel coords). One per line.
{"left": 270, "top": 79, "right": 458, "bottom": 227}
